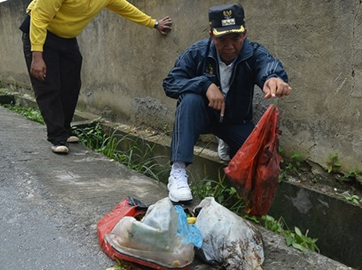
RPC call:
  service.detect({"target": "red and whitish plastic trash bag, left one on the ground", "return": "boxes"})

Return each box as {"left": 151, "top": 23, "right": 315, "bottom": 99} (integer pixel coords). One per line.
{"left": 97, "top": 197, "right": 194, "bottom": 270}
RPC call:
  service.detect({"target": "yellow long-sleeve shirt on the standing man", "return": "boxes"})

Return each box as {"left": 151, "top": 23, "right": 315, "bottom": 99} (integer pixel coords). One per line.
{"left": 27, "top": 0, "right": 156, "bottom": 51}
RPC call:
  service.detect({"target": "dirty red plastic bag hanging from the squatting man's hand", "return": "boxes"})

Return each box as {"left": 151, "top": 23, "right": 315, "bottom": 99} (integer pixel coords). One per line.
{"left": 224, "top": 104, "right": 281, "bottom": 216}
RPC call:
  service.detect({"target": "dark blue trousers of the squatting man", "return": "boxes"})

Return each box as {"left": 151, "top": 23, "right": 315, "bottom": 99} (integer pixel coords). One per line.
{"left": 171, "top": 93, "right": 254, "bottom": 164}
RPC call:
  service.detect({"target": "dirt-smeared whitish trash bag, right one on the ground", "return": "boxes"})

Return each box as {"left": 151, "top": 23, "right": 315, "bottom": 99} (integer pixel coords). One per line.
{"left": 194, "top": 197, "right": 264, "bottom": 270}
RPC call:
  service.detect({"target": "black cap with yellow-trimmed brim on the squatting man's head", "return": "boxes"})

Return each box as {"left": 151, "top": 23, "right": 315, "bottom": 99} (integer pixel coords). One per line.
{"left": 209, "top": 4, "right": 245, "bottom": 37}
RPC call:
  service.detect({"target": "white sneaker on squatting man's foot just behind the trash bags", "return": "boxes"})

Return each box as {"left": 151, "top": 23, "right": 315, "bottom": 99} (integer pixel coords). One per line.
{"left": 167, "top": 169, "right": 192, "bottom": 202}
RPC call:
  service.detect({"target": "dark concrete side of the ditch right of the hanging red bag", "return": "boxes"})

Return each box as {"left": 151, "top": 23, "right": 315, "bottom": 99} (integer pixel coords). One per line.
{"left": 269, "top": 180, "right": 362, "bottom": 269}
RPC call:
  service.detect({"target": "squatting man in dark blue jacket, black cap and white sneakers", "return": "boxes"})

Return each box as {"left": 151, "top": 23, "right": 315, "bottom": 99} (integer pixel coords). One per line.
{"left": 163, "top": 4, "right": 292, "bottom": 202}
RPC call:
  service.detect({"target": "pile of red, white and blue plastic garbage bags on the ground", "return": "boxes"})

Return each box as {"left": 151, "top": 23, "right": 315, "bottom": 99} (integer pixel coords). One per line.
{"left": 97, "top": 197, "right": 264, "bottom": 270}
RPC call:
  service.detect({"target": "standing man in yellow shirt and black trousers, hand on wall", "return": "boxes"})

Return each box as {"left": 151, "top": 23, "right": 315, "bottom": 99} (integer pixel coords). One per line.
{"left": 21, "top": 0, "right": 172, "bottom": 154}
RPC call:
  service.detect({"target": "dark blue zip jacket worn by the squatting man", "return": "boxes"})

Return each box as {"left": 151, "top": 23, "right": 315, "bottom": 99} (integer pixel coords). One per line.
{"left": 163, "top": 38, "right": 288, "bottom": 123}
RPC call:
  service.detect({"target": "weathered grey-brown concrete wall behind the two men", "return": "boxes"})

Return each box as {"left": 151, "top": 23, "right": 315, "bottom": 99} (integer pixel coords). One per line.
{"left": 0, "top": 0, "right": 362, "bottom": 170}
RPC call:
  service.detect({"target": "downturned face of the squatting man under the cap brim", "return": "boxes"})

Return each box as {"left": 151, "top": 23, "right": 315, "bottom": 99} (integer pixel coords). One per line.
{"left": 210, "top": 31, "right": 246, "bottom": 65}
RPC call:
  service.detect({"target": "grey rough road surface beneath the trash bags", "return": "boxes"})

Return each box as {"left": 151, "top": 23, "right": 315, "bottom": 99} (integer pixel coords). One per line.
{"left": 0, "top": 107, "right": 349, "bottom": 270}
